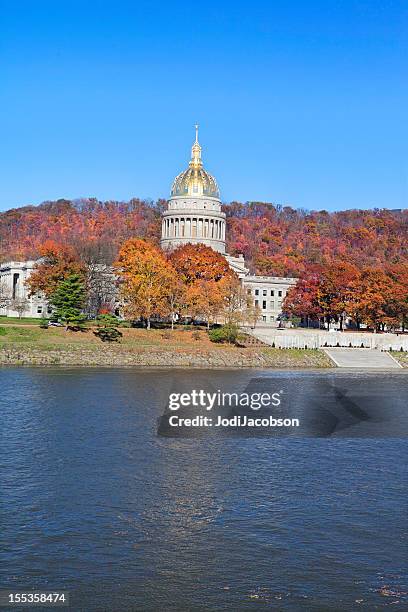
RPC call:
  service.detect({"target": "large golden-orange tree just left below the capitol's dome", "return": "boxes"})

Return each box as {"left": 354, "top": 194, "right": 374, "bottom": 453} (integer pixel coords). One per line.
{"left": 115, "top": 238, "right": 177, "bottom": 329}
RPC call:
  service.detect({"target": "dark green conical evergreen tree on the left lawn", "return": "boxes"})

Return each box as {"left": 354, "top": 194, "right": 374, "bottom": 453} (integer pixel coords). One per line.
{"left": 51, "top": 274, "right": 86, "bottom": 329}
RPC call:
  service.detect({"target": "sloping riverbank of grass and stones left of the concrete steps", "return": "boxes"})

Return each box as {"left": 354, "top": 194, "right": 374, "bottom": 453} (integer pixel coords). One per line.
{"left": 0, "top": 326, "right": 334, "bottom": 368}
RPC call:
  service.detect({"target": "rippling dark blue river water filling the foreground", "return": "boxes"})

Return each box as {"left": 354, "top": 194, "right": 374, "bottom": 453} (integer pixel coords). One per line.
{"left": 0, "top": 369, "right": 408, "bottom": 611}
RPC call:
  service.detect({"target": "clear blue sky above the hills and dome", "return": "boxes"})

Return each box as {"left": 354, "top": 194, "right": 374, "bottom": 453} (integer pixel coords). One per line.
{"left": 0, "top": 0, "right": 408, "bottom": 210}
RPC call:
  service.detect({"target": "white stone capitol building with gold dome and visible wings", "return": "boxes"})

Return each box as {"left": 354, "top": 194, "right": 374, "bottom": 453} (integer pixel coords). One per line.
{"left": 0, "top": 126, "right": 297, "bottom": 326}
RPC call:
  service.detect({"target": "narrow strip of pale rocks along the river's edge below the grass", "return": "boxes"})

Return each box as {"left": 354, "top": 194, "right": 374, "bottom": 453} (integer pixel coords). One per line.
{"left": 0, "top": 346, "right": 335, "bottom": 369}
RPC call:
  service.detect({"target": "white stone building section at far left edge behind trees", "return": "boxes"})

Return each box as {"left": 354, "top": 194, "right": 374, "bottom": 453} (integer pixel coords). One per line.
{"left": 0, "top": 261, "right": 52, "bottom": 319}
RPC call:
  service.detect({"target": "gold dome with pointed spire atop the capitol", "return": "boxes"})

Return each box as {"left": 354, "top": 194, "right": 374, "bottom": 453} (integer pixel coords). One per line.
{"left": 171, "top": 125, "right": 220, "bottom": 199}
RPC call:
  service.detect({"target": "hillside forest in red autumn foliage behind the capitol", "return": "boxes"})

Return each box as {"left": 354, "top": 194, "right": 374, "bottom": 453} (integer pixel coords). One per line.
{"left": 0, "top": 199, "right": 408, "bottom": 276}
